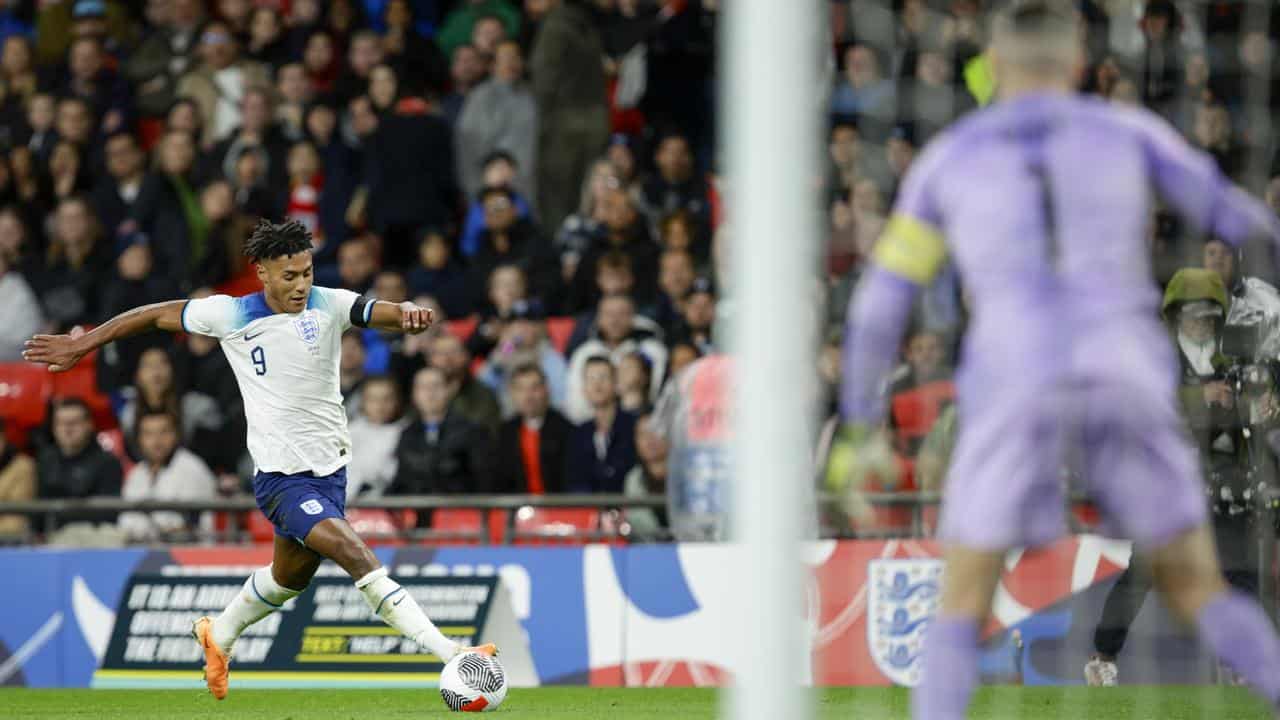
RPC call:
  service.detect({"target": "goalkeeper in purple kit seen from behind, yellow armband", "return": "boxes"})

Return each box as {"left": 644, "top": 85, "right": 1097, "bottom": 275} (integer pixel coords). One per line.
{"left": 842, "top": 0, "right": 1280, "bottom": 720}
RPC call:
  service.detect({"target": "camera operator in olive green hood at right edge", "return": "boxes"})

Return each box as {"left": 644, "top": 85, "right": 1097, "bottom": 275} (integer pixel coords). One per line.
{"left": 1084, "top": 268, "right": 1275, "bottom": 685}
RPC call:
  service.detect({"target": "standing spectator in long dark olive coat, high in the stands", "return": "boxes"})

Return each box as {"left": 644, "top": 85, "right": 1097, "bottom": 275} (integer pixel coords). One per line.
{"left": 529, "top": 0, "right": 609, "bottom": 228}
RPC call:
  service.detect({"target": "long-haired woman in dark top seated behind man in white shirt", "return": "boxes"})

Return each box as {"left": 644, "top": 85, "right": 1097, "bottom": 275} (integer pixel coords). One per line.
{"left": 116, "top": 347, "right": 227, "bottom": 457}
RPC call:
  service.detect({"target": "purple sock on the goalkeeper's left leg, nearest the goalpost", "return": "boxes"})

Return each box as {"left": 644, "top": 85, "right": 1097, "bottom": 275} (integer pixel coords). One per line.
{"left": 911, "top": 616, "right": 978, "bottom": 720}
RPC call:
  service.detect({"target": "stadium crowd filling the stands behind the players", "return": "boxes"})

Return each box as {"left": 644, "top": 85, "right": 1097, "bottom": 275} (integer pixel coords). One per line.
{"left": 0, "top": 0, "right": 1280, "bottom": 541}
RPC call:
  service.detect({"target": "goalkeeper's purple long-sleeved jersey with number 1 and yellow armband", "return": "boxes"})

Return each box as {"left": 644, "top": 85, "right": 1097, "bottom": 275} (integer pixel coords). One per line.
{"left": 841, "top": 95, "right": 1280, "bottom": 421}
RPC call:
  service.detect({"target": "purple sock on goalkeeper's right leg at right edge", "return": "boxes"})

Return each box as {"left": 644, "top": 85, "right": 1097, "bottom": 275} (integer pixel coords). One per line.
{"left": 1196, "top": 591, "right": 1280, "bottom": 706}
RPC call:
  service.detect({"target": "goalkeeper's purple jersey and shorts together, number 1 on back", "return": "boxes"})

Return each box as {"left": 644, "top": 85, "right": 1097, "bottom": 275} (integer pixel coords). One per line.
{"left": 841, "top": 95, "right": 1280, "bottom": 550}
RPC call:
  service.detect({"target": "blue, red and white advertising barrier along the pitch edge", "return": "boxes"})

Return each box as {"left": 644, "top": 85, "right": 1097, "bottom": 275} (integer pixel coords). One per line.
{"left": 0, "top": 536, "right": 1213, "bottom": 686}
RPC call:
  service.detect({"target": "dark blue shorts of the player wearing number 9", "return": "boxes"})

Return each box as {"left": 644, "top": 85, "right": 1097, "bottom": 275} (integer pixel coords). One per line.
{"left": 253, "top": 468, "right": 347, "bottom": 544}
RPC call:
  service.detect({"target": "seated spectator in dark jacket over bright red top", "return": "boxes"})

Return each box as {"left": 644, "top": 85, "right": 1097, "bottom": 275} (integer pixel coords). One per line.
{"left": 493, "top": 364, "right": 572, "bottom": 495}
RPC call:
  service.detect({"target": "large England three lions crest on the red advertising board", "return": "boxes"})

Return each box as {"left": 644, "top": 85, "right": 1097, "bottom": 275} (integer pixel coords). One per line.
{"left": 867, "top": 559, "right": 942, "bottom": 687}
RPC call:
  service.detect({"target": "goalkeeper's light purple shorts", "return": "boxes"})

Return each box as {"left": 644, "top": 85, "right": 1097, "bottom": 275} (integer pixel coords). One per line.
{"left": 938, "top": 368, "right": 1207, "bottom": 551}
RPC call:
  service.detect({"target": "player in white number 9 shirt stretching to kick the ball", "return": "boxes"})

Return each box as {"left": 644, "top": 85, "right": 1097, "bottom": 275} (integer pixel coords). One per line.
{"left": 23, "top": 220, "right": 497, "bottom": 700}
